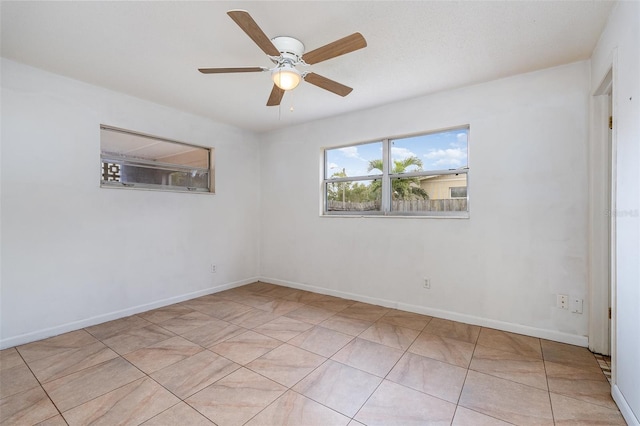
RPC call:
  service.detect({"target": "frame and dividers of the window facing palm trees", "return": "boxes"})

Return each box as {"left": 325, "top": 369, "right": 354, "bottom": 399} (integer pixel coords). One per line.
{"left": 320, "top": 124, "right": 471, "bottom": 219}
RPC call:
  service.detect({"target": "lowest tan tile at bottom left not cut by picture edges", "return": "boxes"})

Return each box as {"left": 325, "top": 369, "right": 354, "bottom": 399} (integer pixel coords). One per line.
{"left": 43, "top": 358, "right": 144, "bottom": 412}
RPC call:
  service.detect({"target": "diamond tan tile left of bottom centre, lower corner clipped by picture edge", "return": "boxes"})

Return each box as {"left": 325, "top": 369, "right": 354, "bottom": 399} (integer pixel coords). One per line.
{"left": 186, "top": 368, "right": 287, "bottom": 426}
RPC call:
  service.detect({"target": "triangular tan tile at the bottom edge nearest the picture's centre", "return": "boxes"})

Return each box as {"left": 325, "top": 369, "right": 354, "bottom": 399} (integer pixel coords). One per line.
{"left": 247, "top": 391, "right": 349, "bottom": 426}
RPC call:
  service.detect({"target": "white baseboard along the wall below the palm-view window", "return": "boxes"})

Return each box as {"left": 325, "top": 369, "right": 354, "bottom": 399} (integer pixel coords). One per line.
{"left": 260, "top": 277, "right": 589, "bottom": 347}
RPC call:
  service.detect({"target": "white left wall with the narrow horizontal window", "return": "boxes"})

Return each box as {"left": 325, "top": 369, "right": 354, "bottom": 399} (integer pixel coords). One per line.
{"left": 0, "top": 59, "right": 260, "bottom": 347}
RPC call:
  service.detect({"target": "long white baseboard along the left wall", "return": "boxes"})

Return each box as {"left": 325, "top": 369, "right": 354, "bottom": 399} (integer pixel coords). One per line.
{"left": 0, "top": 277, "right": 258, "bottom": 349}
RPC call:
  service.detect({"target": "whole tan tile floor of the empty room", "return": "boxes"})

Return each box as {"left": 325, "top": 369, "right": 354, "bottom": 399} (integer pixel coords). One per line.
{"left": 0, "top": 283, "right": 625, "bottom": 426}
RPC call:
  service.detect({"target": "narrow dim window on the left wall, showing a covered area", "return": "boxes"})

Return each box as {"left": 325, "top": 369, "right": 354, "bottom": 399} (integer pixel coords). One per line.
{"left": 100, "top": 126, "right": 214, "bottom": 193}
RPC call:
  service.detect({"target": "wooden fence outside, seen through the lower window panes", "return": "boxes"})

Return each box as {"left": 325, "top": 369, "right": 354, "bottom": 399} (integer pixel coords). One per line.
{"left": 327, "top": 198, "right": 467, "bottom": 212}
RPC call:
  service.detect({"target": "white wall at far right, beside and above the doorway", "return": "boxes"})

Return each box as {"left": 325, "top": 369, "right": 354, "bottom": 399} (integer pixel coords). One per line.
{"left": 591, "top": 2, "right": 640, "bottom": 425}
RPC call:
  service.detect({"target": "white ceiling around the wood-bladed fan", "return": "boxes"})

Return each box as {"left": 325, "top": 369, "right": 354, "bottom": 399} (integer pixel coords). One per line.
{"left": 1, "top": 0, "right": 613, "bottom": 131}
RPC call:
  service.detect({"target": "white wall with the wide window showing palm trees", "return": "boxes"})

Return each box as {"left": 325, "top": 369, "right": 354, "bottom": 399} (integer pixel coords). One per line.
{"left": 260, "top": 62, "right": 589, "bottom": 346}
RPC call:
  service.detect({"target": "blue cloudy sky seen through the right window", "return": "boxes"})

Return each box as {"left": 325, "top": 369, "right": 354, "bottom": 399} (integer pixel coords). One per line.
{"left": 326, "top": 129, "right": 469, "bottom": 177}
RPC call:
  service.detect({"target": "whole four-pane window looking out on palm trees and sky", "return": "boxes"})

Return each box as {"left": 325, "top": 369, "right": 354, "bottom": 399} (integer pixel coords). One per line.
{"left": 323, "top": 127, "right": 469, "bottom": 217}
